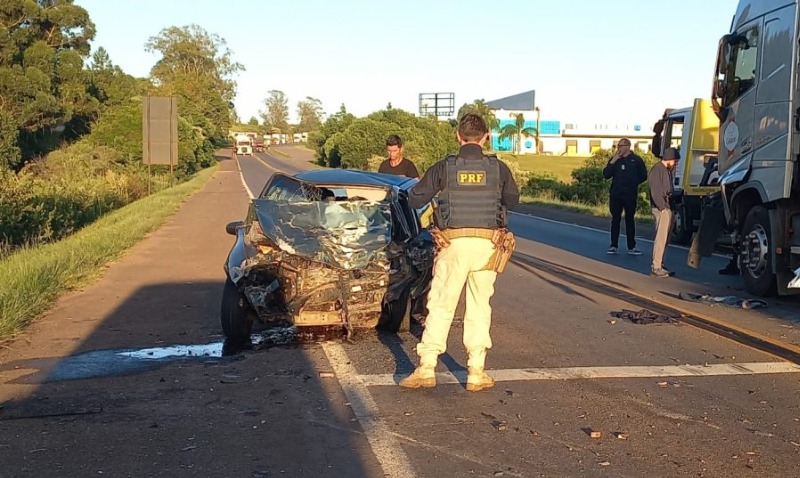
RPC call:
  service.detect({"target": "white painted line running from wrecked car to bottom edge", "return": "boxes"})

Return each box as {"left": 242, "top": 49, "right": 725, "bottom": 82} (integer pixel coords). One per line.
{"left": 322, "top": 342, "right": 416, "bottom": 477}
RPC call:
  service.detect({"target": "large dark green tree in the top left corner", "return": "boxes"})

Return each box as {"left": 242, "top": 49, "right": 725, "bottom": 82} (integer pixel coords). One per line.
{"left": 0, "top": 0, "right": 96, "bottom": 169}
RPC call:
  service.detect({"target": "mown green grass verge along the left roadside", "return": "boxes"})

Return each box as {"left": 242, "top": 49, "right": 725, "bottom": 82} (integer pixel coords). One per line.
{"left": 0, "top": 167, "right": 217, "bottom": 341}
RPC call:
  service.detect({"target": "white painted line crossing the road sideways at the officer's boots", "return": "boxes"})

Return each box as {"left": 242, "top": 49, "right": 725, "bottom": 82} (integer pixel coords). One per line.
{"left": 361, "top": 362, "right": 800, "bottom": 386}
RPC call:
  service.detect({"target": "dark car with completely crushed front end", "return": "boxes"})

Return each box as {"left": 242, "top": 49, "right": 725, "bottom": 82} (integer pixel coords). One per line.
{"left": 221, "top": 169, "right": 434, "bottom": 340}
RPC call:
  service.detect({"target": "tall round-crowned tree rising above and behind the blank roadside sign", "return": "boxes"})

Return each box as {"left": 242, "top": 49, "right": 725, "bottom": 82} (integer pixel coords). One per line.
{"left": 145, "top": 25, "right": 244, "bottom": 141}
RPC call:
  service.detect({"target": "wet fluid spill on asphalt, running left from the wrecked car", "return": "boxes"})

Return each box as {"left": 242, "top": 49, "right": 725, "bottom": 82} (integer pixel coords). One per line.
{"left": 0, "top": 327, "right": 342, "bottom": 384}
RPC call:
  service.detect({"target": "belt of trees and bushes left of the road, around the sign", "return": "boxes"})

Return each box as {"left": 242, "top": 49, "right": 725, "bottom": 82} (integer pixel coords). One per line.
{"left": 0, "top": 0, "right": 242, "bottom": 252}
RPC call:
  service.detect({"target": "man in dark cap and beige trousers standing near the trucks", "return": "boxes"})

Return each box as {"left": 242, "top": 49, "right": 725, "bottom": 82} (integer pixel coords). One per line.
{"left": 647, "top": 148, "right": 681, "bottom": 277}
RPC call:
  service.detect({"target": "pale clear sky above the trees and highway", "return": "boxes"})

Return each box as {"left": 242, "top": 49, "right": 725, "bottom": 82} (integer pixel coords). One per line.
{"left": 75, "top": 0, "right": 737, "bottom": 126}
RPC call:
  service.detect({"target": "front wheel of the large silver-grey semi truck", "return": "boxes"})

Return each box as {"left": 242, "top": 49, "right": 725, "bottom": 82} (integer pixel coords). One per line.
{"left": 741, "top": 206, "right": 777, "bottom": 297}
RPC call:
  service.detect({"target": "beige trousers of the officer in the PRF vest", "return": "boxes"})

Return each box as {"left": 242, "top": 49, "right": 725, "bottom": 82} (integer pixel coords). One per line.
{"left": 417, "top": 237, "right": 497, "bottom": 368}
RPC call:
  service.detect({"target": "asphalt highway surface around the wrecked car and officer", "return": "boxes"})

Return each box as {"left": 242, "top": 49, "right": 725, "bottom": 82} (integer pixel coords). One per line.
{"left": 0, "top": 149, "right": 800, "bottom": 477}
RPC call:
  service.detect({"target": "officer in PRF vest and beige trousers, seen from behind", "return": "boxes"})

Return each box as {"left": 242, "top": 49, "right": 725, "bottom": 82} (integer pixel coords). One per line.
{"left": 400, "top": 113, "right": 519, "bottom": 391}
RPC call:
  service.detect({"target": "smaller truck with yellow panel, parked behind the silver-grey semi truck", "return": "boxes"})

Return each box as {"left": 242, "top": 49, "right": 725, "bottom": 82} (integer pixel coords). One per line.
{"left": 653, "top": 98, "right": 719, "bottom": 245}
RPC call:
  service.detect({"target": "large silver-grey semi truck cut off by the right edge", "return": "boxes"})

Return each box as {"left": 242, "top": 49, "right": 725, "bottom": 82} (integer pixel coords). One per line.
{"left": 689, "top": 0, "right": 800, "bottom": 296}
